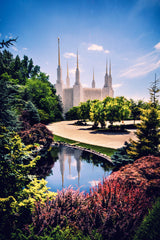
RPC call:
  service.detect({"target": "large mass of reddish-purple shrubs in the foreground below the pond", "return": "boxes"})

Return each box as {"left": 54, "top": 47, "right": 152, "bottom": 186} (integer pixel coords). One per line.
{"left": 12, "top": 156, "right": 160, "bottom": 240}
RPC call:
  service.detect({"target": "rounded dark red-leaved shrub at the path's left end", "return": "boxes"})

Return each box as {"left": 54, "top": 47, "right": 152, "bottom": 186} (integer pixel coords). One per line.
{"left": 19, "top": 123, "right": 53, "bottom": 147}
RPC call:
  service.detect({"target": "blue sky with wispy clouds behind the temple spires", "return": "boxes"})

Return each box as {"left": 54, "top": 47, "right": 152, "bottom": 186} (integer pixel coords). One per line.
{"left": 0, "top": 0, "right": 160, "bottom": 101}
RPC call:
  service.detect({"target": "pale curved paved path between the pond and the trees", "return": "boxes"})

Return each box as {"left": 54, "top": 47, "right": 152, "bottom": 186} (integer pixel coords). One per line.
{"left": 47, "top": 121, "right": 136, "bottom": 149}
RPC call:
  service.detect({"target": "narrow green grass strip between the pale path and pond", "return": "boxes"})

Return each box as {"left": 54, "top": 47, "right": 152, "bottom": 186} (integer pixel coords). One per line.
{"left": 54, "top": 135, "right": 116, "bottom": 156}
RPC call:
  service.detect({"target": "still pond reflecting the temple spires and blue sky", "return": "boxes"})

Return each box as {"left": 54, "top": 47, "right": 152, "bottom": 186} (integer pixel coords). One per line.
{"left": 35, "top": 145, "right": 112, "bottom": 191}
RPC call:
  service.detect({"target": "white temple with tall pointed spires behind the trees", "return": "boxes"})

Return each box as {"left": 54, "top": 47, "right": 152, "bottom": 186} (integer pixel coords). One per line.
{"left": 55, "top": 38, "right": 114, "bottom": 113}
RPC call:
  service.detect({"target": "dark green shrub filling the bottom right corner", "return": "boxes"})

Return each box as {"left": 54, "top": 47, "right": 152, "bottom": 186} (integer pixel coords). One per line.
{"left": 133, "top": 198, "right": 160, "bottom": 240}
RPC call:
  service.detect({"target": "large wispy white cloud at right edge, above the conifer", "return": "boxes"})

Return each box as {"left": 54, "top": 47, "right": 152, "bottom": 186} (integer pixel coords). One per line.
{"left": 120, "top": 47, "right": 160, "bottom": 78}
